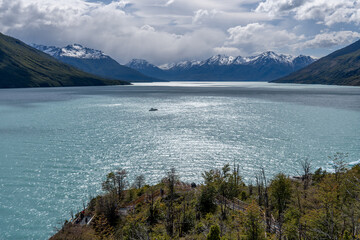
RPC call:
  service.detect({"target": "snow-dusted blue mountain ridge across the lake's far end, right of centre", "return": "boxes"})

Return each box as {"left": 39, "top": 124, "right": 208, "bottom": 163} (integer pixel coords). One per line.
{"left": 126, "top": 51, "right": 316, "bottom": 81}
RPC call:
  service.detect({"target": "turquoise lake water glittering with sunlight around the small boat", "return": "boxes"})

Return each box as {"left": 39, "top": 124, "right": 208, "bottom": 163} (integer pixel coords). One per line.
{"left": 0, "top": 82, "right": 360, "bottom": 239}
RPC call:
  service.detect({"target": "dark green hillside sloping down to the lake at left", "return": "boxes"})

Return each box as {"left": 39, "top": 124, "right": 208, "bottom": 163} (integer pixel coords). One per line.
{"left": 0, "top": 33, "right": 129, "bottom": 88}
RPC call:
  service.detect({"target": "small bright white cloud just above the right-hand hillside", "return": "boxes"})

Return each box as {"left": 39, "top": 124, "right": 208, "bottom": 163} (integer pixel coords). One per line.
{"left": 297, "top": 31, "right": 360, "bottom": 48}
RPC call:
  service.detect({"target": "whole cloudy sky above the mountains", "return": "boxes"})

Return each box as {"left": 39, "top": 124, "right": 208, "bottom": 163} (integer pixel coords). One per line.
{"left": 0, "top": 0, "right": 360, "bottom": 64}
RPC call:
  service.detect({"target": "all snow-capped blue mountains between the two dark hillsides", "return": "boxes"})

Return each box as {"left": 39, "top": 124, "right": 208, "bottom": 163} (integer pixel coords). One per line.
{"left": 32, "top": 44, "right": 315, "bottom": 82}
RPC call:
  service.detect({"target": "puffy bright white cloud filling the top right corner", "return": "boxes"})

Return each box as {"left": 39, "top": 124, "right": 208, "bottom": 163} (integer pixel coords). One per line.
{"left": 256, "top": 0, "right": 360, "bottom": 26}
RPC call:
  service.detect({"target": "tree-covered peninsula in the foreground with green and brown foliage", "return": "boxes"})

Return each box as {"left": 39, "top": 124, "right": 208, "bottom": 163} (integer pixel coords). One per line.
{"left": 51, "top": 153, "right": 360, "bottom": 240}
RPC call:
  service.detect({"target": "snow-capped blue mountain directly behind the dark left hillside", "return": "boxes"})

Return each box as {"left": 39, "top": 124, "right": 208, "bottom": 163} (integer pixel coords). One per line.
{"left": 32, "top": 44, "right": 160, "bottom": 82}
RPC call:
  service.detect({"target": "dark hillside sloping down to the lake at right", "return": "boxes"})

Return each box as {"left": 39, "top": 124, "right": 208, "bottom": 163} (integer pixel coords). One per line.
{"left": 274, "top": 40, "right": 360, "bottom": 86}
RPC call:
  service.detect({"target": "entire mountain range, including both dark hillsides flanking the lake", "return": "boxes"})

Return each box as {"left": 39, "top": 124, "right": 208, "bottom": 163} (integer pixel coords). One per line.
{"left": 0, "top": 33, "right": 360, "bottom": 88}
